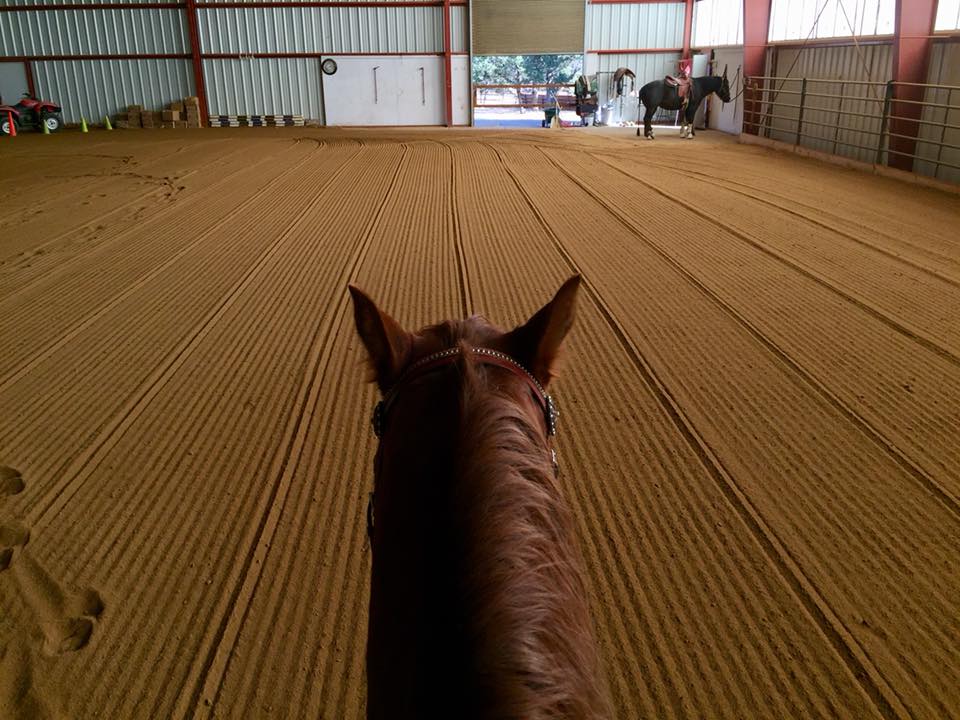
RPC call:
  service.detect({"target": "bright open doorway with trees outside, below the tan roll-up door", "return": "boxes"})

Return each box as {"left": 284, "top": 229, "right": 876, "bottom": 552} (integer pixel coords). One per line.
{"left": 472, "top": 54, "right": 583, "bottom": 128}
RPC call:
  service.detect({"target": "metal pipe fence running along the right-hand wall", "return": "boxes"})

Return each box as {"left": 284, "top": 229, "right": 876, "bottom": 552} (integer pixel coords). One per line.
{"left": 743, "top": 75, "right": 960, "bottom": 177}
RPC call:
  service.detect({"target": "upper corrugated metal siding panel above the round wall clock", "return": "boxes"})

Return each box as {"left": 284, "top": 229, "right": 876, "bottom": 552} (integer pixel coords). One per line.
{"left": 197, "top": 7, "right": 443, "bottom": 54}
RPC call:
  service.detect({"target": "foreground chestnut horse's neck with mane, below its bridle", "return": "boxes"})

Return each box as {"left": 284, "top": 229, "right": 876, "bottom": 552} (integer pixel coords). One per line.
{"left": 368, "top": 363, "right": 603, "bottom": 718}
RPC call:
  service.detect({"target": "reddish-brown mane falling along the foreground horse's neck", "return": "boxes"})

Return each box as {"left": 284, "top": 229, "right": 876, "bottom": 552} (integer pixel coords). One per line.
{"left": 451, "top": 340, "right": 606, "bottom": 720}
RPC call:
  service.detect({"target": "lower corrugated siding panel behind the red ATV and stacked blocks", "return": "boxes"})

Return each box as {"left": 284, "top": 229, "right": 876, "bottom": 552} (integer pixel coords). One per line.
{"left": 33, "top": 60, "right": 195, "bottom": 122}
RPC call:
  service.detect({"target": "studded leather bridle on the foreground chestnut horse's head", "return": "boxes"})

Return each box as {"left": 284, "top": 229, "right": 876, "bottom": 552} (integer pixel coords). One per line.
{"left": 367, "top": 347, "right": 560, "bottom": 542}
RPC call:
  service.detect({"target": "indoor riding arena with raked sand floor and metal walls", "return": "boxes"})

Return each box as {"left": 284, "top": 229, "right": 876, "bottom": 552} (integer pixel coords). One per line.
{"left": 0, "top": 0, "right": 960, "bottom": 720}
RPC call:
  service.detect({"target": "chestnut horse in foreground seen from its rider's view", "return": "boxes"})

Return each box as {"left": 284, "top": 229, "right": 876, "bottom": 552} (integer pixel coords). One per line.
{"left": 350, "top": 277, "right": 608, "bottom": 720}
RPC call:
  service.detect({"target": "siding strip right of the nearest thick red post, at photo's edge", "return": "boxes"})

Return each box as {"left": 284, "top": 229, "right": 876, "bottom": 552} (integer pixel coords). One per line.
{"left": 914, "top": 42, "right": 960, "bottom": 183}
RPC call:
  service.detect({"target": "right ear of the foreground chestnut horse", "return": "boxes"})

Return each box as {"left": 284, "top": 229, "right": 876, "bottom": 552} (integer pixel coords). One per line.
{"left": 507, "top": 275, "right": 580, "bottom": 387}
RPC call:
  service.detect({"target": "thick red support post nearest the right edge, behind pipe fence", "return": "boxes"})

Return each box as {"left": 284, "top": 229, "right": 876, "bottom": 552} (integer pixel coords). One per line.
{"left": 887, "top": 0, "right": 937, "bottom": 170}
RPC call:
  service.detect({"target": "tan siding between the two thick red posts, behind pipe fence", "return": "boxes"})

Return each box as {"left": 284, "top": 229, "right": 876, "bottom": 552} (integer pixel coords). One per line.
{"left": 770, "top": 45, "right": 892, "bottom": 162}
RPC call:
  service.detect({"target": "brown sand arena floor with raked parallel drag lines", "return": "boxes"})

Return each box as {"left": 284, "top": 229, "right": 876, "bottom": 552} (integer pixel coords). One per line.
{"left": 0, "top": 128, "right": 960, "bottom": 720}
